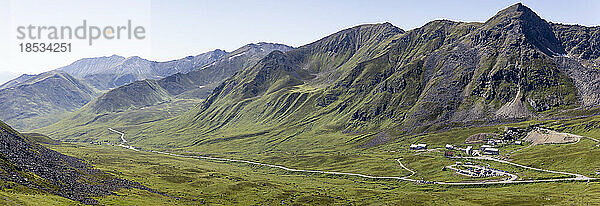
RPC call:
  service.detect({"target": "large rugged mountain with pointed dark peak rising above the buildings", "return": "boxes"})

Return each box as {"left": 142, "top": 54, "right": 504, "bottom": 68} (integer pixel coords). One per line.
{"left": 144, "top": 4, "right": 600, "bottom": 148}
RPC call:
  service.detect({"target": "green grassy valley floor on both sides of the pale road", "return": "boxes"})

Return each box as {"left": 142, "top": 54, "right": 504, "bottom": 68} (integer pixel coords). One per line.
{"left": 11, "top": 117, "right": 600, "bottom": 205}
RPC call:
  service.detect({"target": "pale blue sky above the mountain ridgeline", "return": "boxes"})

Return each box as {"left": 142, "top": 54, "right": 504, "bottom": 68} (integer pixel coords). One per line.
{"left": 0, "top": 0, "right": 600, "bottom": 74}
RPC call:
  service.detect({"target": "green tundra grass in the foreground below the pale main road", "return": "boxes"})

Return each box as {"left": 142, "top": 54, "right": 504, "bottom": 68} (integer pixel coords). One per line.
{"left": 42, "top": 144, "right": 600, "bottom": 205}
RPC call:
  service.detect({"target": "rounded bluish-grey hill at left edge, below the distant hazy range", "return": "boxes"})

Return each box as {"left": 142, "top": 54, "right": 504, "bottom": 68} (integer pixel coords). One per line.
{"left": 0, "top": 71, "right": 96, "bottom": 130}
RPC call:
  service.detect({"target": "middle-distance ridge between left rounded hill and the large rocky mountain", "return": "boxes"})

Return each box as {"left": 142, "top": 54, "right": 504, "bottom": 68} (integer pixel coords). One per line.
{"left": 36, "top": 43, "right": 292, "bottom": 141}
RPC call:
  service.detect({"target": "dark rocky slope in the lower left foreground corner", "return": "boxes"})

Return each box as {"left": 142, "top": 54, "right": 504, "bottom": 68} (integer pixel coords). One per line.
{"left": 0, "top": 122, "right": 148, "bottom": 204}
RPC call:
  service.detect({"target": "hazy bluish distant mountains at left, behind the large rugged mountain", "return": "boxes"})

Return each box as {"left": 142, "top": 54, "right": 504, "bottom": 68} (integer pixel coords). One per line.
{"left": 0, "top": 43, "right": 292, "bottom": 130}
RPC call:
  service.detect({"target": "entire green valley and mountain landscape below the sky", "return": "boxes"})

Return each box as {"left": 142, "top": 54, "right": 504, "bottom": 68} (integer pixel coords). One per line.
{"left": 0, "top": 3, "right": 600, "bottom": 205}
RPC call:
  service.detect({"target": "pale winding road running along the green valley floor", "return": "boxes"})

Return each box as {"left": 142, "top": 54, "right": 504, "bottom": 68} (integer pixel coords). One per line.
{"left": 109, "top": 128, "right": 596, "bottom": 185}
